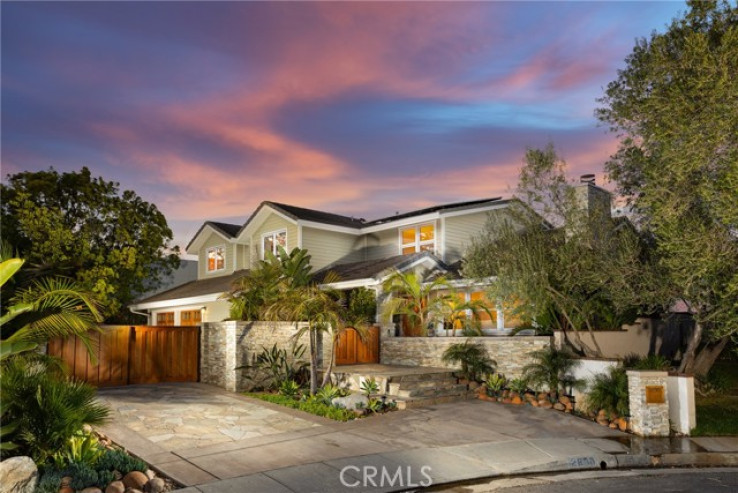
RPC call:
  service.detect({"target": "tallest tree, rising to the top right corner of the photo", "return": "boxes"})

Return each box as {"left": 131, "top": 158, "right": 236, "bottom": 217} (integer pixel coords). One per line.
{"left": 598, "top": 1, "right": 738, "bottom": 374}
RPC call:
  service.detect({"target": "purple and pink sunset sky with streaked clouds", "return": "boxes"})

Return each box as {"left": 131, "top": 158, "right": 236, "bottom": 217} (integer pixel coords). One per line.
{"left": 1, "top": 2, "right": 686, "bottom": 250}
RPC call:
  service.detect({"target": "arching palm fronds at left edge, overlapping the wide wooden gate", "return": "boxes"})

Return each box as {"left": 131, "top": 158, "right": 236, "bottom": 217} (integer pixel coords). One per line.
{"left": 0, "top": 258, "right": 102, "bottom": 361}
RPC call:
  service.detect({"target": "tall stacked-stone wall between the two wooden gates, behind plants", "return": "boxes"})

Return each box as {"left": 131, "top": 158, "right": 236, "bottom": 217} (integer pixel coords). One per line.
{"left": 200, "top": 321, "right": 331, "bottom": 391}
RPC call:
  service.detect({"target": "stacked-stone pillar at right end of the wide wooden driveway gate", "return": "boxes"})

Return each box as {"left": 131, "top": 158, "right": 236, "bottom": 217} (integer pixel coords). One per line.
{"left": 200, "top": 321, "right": 238, "bottom": 391}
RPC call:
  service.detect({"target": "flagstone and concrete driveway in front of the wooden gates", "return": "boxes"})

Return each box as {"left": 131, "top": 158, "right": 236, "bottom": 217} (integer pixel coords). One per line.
{"left": 99, "top": 384, "right": 627, "bottom": 485}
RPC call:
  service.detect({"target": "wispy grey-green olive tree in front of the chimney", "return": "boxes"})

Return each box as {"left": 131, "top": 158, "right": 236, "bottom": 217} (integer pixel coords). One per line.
{"left": 463, "top": 145, "right": 661, "bottom": 356}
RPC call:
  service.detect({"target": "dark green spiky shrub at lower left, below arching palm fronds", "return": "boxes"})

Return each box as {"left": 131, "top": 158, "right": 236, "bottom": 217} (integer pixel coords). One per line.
{"left": 0, "top": 357, "right": 109, "bottom": 464}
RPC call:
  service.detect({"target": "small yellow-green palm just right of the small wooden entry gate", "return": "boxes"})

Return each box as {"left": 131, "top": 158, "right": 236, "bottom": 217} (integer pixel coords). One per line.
{"left": 382, "top": 271, "right": 451, "bottom": 336}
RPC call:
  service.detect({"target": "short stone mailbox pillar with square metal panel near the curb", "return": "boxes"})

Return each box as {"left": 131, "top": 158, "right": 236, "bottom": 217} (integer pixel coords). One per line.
{"left": 627, "top": 370, "right": 669, "bottom": 437}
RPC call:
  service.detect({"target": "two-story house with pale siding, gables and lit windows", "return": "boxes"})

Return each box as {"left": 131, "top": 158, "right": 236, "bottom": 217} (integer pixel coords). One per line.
{"left": 131, "top": 194, "right": 524, "bottom": 328}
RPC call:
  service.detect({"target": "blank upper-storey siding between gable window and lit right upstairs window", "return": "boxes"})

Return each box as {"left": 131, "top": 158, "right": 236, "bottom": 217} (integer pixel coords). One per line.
{"left": 302, "top": 227, "right": 364, "bottom": 270}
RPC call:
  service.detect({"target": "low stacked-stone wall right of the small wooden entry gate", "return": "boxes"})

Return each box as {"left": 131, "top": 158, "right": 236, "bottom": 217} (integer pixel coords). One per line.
{"left": 380, "top": 336, "right": 551, "bottom": 378}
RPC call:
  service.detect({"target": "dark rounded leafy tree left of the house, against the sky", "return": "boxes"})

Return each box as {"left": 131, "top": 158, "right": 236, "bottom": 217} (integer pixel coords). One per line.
{"left": 1, "top": 168, "right": 179, "bottom": 317}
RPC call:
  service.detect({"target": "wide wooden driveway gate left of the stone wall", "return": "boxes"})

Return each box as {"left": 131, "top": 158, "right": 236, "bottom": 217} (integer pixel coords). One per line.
{"left": 47, "top": 325, "right": 200, "bottom": 387}
